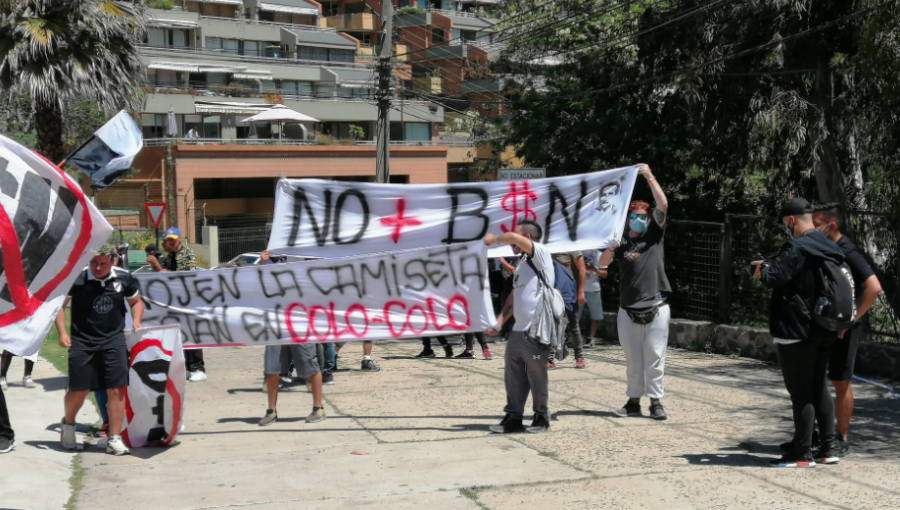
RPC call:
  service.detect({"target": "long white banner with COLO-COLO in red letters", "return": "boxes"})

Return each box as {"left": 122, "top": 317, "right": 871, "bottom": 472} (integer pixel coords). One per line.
{"left": 134, "top": 241, "right": 495, "bottom": 348}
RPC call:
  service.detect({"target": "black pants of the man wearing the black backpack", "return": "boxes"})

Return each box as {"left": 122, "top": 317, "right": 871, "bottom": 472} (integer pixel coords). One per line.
{"left": 778, "top": 334, "right": 835, "bottom": 454}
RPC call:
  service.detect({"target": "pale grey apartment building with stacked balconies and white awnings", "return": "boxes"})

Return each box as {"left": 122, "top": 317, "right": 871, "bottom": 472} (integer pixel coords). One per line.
{"left": 141, "top": 0, "right": 444, "bottom": 143}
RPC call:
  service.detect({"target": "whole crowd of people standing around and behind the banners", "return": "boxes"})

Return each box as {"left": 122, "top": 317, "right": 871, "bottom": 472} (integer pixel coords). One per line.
{"left": 0, "top": 165, "right": 881, "bottom": 467}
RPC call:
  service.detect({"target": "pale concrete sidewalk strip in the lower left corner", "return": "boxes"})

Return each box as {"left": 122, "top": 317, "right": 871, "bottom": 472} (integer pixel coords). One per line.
{"left": 0, "top": 358, "right": 99, "bottom": 510}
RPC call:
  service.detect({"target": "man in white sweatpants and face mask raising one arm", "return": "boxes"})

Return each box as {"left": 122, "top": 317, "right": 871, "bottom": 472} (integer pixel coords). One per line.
{"left": 600, "top": 165, "right": 672, "bottom": 420}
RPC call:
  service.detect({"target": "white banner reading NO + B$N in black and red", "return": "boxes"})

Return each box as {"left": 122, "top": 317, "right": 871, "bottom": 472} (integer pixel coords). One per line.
{"left": 268, "top": 166, "right": 637, "bottom": 257}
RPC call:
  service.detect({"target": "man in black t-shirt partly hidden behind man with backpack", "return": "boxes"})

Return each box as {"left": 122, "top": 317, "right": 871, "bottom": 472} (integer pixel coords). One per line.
{"left": 813, "top": 203, "right": 881, "bottom": 457}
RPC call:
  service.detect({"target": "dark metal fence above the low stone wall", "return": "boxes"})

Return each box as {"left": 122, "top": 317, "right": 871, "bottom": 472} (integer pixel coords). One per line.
{"left": 603, "top": 212, "right": 900, "bottom": 343}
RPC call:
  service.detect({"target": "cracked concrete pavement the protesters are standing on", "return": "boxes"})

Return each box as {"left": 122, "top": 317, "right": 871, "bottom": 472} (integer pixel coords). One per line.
{"left": 0, "top": 343, "right": 900, "bottom": 510}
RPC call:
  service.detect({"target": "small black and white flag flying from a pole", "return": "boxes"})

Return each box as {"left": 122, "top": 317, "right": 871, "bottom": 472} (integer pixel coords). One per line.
{"left": 65, "top": 111, "right": 144, "bottom": 190}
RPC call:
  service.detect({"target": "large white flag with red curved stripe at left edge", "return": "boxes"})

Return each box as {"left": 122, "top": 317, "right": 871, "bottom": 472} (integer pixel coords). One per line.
{"left": 0, "top": 136, "right": 112, "bottom": 356}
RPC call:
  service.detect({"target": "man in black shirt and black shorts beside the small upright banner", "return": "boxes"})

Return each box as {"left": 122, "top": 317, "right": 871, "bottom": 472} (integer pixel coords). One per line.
{"left": 56, "top": 244, "right": 144, "bottom": 455}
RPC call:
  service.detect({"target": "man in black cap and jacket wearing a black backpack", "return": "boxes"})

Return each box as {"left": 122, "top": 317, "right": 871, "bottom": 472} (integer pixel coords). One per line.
{"left": 753, "top": 198, "right": 854, "bottom": 467}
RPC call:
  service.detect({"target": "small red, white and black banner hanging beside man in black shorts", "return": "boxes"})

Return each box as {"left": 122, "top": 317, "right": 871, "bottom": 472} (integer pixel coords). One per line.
{"left": 122, "top": 326, "right": 185, "bottom": 448}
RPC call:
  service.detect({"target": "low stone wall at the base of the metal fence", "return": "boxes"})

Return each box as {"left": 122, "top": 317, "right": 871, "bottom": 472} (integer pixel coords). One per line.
{"left": 596, "top": 312, "right": 900, "bottom": 380}
